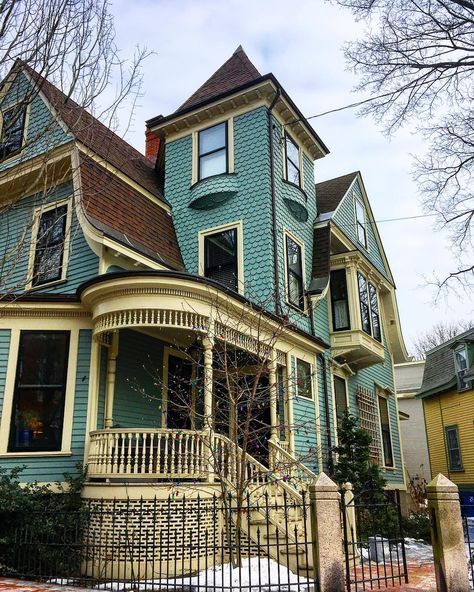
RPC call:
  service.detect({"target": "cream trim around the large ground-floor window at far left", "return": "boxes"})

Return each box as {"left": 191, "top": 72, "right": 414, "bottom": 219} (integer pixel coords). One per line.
{"left": 0, "top": 326, "right": 79, "bottom": 457}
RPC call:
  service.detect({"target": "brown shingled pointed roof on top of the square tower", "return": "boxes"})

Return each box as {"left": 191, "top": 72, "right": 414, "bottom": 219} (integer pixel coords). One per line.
{"left": 176, "top": 45, "right": 261, "bottom": 113}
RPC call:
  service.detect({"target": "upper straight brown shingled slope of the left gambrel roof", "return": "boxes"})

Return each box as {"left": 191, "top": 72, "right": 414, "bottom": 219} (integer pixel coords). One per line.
{"left": 23, "top": 64, "right": 167, "bottom": 203}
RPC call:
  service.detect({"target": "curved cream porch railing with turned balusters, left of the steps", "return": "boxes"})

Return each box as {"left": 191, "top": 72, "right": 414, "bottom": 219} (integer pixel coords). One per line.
{"left": 87, "top": 428, "right": 209, "bottom": 480}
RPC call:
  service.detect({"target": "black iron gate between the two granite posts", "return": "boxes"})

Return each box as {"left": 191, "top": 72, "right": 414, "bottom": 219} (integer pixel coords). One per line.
{"left": 341, "top": 490, "right": 408, "bottom": 592}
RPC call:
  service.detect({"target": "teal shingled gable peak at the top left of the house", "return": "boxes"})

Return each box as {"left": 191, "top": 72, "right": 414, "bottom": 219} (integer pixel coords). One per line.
{"left": 0, "top": 72, "right": 72, "bottom": 173}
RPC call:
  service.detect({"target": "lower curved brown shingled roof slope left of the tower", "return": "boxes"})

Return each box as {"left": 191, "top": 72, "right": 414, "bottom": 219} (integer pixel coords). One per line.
{"left": 80, "top": 154, "right": 184, "bottom": 270}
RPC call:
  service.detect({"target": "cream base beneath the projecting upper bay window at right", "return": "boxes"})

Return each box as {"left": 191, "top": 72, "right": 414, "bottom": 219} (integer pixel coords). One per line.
{"left": 331, "top": 329, "right": 385, "bottom": 368}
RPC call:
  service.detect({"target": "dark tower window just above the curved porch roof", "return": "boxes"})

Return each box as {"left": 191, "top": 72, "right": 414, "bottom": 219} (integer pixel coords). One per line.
{"left": 204, "top": 228, "right": 239, "bottom": 291}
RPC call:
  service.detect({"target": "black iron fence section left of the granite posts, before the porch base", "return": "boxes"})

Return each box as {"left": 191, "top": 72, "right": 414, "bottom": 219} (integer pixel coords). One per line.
{"left": 0, "top": 493, "right": 318, "bottom": 592}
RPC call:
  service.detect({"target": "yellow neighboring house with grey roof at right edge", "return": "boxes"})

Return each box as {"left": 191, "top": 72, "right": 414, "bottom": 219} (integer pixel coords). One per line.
{"left": 417, "top": 329, "right": 474, "bottom": 498}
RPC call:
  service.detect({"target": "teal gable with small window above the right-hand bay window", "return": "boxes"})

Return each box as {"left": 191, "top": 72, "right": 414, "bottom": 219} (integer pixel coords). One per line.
{"left": 332, "top": 176, "right": 391, "bottom": 280}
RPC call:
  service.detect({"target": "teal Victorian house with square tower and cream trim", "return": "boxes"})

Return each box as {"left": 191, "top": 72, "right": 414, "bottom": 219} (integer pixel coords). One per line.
{"left": 0, "top": 47, "right": 406, "bottom": 572}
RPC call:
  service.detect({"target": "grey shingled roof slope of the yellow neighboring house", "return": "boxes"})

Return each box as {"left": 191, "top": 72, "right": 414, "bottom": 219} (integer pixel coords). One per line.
{"left": 418, "top": 329, "right": 474, "bottom": 397}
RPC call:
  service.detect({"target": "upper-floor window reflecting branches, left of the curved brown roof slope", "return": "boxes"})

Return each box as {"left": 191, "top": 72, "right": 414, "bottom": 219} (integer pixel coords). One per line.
{"left": 31, "top": 204, "right": 68, "bottom": 287}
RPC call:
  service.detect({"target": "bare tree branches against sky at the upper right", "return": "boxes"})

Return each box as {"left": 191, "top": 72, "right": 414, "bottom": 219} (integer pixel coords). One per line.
{"left": 335, "top": 0, "right": 474, "bottom": 289}
